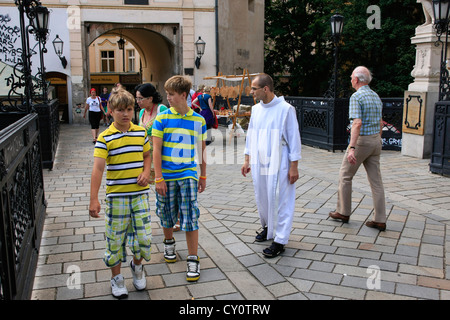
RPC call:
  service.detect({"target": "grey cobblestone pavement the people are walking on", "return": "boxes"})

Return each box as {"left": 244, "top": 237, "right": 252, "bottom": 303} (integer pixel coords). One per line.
{"left": 32, "top": 125, "right": 450, "bottom": 300}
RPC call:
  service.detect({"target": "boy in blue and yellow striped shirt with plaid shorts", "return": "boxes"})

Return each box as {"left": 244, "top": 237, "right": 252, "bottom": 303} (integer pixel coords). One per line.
{"left": 152, "top": 76, "right": 206, "bottom": 282}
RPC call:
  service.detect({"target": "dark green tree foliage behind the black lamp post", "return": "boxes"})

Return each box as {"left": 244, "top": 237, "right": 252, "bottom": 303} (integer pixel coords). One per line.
{"left": 265, "top": 0, "right": 424, "bottom": 97}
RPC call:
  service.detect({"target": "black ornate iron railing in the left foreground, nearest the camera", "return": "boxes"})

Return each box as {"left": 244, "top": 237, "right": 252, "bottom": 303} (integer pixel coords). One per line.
{"left": 0, "top": 113, "right": 46, "bottom": 300}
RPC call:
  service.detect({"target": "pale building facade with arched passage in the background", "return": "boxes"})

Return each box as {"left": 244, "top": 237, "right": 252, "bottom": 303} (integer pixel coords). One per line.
{"left": 0, "top": 0, "right": 264, "bottom": 123}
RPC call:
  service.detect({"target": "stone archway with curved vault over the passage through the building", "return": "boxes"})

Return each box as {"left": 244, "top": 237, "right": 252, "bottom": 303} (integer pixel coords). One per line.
{"left": 83, "top": 22, "right": 182, "bottom": 92}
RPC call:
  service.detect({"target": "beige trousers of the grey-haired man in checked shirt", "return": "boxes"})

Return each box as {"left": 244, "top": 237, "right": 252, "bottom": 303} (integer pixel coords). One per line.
{"left": 336, "top": 134, "right": 386, "bottom": 223}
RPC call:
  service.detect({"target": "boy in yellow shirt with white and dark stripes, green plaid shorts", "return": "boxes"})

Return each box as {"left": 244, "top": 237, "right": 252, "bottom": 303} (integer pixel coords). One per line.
{"left": 89, "top": 89, "right": 152, "bottom": 298}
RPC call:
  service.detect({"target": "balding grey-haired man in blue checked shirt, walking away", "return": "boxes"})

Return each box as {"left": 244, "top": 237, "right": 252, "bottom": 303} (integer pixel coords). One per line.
{"left": 329, "top": 66, "right": 386, "bottom": 231}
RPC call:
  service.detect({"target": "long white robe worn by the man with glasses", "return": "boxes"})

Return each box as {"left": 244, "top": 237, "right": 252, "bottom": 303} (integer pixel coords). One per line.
{"left": 244, "top": 96, "right": 301, "bottom": 244}
